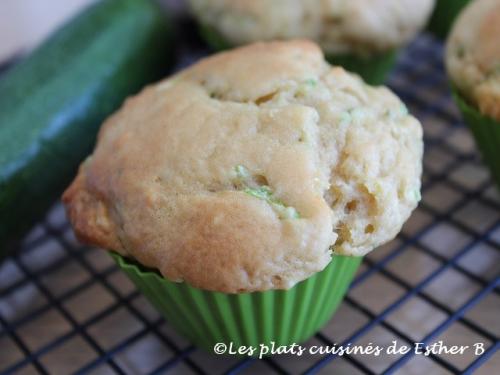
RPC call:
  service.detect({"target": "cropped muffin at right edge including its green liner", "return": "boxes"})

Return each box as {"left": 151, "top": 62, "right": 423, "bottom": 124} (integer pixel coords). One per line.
{"left": 446, "top": 0, "right": 500, "bottom": 186}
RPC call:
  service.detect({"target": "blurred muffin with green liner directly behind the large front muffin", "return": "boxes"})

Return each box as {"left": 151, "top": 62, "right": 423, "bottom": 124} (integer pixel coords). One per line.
{"left": 189, "top": 0, "right": 434, "bottom": 84}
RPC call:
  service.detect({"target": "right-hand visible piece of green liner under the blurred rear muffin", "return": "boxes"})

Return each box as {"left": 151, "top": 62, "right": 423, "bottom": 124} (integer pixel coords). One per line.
{"left": 326, "top": 50, "right": 398, "bottom": 85}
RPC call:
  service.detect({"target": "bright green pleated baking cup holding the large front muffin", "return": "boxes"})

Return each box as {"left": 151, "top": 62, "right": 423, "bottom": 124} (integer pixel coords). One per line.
{"left": 110, "top": 252, "right": 361, "bottom": 352}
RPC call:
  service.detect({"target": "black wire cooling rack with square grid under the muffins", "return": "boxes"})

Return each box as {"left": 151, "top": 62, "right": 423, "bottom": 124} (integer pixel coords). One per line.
{"left": 0, "top": 27, "right": 500, "bottom": 375}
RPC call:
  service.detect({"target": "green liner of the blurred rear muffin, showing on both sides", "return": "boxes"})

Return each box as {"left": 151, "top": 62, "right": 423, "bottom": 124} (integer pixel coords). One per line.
{"left": 199, "top": 24, "right": 397, "bottom": 85}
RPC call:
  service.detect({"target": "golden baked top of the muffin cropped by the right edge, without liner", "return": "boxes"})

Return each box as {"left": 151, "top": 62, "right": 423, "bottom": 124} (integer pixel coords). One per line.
{"left": 446, "top": 0, "right": 500, "bottom": 121}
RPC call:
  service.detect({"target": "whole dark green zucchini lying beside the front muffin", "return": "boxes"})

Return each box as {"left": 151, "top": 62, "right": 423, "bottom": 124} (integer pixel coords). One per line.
{"left": 0, "top": 0, "right": 172, "bottom": 259}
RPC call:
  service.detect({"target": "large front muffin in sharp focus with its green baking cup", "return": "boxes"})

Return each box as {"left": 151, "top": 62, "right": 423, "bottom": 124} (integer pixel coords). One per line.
{"left": 63, "top": 40, "right": 422, "bottom": 350}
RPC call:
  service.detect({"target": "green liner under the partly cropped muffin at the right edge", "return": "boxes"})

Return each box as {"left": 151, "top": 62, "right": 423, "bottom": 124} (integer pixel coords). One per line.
{"left": 452, "top": 89, "right": 500, "bottom": 188}
